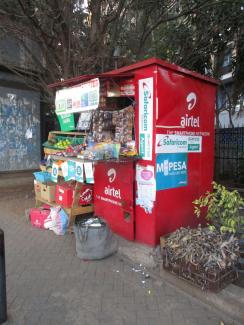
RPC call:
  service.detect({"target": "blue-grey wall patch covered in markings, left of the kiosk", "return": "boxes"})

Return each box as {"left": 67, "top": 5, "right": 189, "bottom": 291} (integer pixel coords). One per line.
{"left": 0, "top": 87, "right": 40, "bottom": 171}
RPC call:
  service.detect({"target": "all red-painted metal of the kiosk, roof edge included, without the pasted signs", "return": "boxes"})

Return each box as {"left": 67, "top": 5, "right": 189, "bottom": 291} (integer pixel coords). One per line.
{"left": 47, "top": 58, "right": 218, "bottom": 246}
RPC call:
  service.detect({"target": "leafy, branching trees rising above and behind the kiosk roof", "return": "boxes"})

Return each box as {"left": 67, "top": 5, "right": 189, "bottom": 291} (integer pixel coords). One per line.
{"left": 0, "top": 0, "right": 244, "bottom": 110}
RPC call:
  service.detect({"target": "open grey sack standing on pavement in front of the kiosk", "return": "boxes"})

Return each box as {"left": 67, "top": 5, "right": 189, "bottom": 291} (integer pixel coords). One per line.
{"left": 74, "top": 218, "right": 118, "bottom": 260}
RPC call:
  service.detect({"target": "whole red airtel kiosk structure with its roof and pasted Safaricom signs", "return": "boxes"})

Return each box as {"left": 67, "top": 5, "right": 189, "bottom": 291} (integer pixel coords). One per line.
{"left": 48, "top": 58, "right": 218, "bottom": 246}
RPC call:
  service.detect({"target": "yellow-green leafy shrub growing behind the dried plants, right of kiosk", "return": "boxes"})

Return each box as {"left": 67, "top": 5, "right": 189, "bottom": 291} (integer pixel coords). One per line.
{"left": 193, "top": 182, "right": 244, "bottom": 233}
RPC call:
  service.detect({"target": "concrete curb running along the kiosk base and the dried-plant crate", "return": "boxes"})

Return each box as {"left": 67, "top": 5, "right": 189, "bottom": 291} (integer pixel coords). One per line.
{"left": 118, "top": 238, "right": 244, "bottom": 324}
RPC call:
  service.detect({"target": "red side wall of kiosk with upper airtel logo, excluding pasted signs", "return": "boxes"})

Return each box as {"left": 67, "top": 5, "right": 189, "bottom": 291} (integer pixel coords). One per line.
{"left": 155, "top": 68, "right": 216, "bottom": 242}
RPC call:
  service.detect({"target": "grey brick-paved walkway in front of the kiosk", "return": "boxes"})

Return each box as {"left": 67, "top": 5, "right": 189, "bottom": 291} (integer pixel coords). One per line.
{"left": 0, "top": 194, "right": 240, "bottom": 325}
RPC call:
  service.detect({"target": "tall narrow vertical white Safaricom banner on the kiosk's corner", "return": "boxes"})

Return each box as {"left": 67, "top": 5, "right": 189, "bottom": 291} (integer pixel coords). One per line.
{"left": 139, "top": 78, "right": 153, "bottom": 160}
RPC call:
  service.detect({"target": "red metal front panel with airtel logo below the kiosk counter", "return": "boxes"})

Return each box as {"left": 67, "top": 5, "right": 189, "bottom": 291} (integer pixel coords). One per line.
{"left": 94, "top": 162, "right": 134, "bottom": 240}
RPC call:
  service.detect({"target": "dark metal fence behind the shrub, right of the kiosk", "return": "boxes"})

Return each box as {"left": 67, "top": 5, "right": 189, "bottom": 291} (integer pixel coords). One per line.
{"left": 214, "top": 128, "right": 244, "bottom": 187}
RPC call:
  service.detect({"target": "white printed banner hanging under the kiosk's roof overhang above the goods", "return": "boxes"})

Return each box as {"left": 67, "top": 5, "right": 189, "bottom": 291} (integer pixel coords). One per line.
{"left": 55, "top": 78, "right": 100, "bottom": 115}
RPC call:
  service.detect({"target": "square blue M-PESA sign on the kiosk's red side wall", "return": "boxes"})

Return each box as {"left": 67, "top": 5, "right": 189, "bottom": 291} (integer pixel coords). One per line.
{"left": 156, "top": 153, "right": 188, "bottom": 191}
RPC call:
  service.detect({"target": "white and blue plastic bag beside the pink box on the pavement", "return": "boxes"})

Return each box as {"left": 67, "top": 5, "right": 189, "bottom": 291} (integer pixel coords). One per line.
{"left": 44, "top": 206, "right": 69, "bottom": 235}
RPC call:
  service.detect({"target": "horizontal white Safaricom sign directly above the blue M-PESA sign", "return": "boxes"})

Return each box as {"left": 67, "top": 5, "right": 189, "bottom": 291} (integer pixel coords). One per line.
{"left": 155, "top": 134, "right": 202, "bottom": 153}
